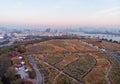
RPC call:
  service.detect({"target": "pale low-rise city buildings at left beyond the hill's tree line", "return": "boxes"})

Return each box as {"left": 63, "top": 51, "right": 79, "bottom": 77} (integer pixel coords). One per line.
{"left": 0, "top": 29, "right": 66, "bottom": 46}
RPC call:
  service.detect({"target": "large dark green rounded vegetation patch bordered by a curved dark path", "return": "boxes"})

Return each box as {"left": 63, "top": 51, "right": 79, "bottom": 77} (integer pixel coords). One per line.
{"left": 64, "top": 56, "right": 95, "bottom": 80}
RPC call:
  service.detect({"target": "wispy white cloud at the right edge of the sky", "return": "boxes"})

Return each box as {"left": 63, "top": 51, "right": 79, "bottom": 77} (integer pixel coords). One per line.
{"left": 89, "top": 7, "right": 120, "bottom": 24}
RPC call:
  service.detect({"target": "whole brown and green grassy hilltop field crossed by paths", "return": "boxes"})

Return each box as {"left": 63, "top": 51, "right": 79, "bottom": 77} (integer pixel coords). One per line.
{"left": 27, "top": 39, "right": 119, "bottom": 84}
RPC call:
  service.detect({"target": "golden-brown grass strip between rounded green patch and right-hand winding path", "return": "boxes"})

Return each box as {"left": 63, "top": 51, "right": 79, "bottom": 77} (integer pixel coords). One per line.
{"left": 84, "top": 56, "right": 109, "bottom": 84}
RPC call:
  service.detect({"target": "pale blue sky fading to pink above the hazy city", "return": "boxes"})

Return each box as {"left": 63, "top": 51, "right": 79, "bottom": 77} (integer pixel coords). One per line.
{"left": 0, "top": 0, "right": 120, "bottom": 26}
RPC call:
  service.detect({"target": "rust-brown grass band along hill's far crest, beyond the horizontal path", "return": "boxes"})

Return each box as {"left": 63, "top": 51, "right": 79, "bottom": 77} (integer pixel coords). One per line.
{"left": 27, "top": 40, "right": 97, "bottom": 53}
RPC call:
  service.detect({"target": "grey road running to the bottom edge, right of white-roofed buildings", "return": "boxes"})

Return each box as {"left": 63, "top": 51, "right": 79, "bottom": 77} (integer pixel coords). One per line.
{"left": 28, "top": 55, "right": 44, "bottom": 84}
